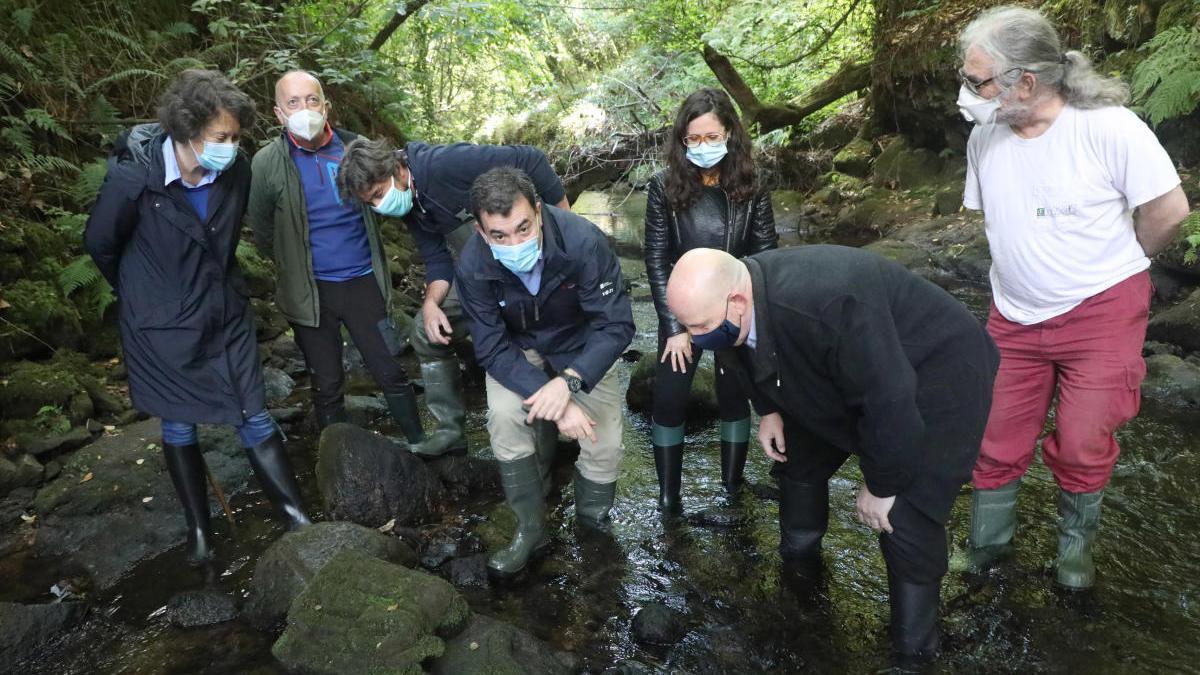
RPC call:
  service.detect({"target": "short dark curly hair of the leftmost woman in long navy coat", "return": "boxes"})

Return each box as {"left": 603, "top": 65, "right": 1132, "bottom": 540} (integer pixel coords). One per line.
{"left": 158, "top": 68, "right": 254, "bottom": 141}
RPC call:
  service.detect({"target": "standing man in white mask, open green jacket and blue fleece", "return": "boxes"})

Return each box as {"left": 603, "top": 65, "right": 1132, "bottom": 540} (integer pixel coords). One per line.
{"left": 247, "top": 71, "right": 425, "bottom": 443}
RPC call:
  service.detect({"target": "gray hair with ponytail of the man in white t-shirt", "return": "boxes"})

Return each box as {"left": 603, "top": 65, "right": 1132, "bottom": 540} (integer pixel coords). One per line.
{"left": 959, "top": 6, "right": 1129, "bottom": 108}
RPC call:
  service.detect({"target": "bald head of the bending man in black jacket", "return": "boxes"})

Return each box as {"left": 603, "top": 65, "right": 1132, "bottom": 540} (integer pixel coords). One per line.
{"left": 667, "top": 249, "right": 754, "bottom": 344}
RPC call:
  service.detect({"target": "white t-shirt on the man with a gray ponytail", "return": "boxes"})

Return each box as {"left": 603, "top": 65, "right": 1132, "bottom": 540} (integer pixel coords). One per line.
{"left": 962, "top": 106, "right": 1180, "bottom": 325}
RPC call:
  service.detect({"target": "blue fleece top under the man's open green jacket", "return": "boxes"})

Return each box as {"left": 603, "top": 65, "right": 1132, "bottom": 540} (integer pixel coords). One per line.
{"left": 288, "top": 127, "right": 372, "bottom": 281}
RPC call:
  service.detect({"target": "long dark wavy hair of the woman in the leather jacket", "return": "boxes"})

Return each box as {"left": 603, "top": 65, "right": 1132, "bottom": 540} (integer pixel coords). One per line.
{"left": 665, "top": 86, "right": 757, "bottom": 210}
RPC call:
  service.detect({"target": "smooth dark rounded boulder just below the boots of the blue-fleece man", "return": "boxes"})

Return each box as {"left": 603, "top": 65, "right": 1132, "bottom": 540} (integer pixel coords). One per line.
{"left": 317, "top": 424, "right": 443, "bottom": 527}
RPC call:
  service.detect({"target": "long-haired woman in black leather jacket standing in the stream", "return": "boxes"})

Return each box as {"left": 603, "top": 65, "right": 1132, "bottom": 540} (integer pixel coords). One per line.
{"left": 646, "top": 89, "right": 779, "bottom": 513}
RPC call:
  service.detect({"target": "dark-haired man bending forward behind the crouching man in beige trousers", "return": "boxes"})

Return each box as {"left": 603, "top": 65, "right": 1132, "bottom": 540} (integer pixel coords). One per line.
{"left": 337, "top": 138, "right": 566, "bottom": 456}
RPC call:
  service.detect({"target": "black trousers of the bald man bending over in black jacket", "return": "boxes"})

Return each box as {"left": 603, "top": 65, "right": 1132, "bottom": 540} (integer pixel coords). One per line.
{"left": 772, "top": 437, "right": 958, "bottom": 584}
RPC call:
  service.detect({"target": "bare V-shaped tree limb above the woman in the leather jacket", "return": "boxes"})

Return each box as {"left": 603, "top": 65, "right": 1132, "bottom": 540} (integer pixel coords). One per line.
{"left": 704, "top": 43, "right": 871, "bottom": 133}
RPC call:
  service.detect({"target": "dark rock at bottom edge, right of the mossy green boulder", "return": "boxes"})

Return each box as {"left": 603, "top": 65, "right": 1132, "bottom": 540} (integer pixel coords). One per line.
{"left": 428, "top": 614, "right": 578, "bottom": 675}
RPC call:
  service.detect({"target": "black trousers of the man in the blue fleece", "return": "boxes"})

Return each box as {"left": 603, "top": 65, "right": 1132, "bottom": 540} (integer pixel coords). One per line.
{"left": 292, "top": 274, "right": 409, "bottom": 410}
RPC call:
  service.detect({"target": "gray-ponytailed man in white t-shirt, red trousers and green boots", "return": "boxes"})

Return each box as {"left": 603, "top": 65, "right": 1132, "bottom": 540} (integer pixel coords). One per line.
{"left": 959, "top": 7, "right": 1188, "bottom": 590}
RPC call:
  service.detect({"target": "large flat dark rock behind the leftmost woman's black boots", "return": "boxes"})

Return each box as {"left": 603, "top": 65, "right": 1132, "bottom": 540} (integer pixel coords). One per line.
{"left": 34, "top": 420, "right": 250, "bottom": 590}
